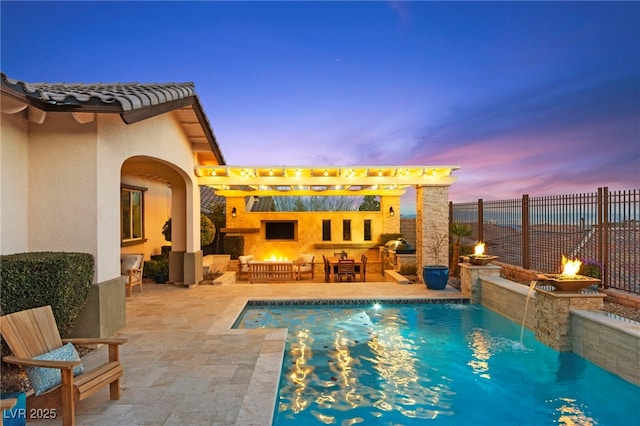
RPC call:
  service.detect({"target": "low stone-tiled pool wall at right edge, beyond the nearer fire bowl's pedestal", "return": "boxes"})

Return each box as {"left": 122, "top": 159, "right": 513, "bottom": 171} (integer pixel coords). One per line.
{"left": 571, "top": 311, "right": 640, "bottom": 386}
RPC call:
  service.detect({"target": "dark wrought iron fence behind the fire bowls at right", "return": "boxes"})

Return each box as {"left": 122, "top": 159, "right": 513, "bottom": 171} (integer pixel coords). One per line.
{"left": 449, "top": 187, "right": 640, "bottom": 293}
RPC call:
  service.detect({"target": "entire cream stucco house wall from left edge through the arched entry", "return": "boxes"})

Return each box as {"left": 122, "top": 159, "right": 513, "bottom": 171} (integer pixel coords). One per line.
{"left": 1, "top": 112, "right": 200, "bottom": 282}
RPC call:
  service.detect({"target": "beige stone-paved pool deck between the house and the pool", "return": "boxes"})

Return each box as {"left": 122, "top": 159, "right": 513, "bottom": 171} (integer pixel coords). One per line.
{"left": 29, "top": 281, "right": 460, "bottom": 426}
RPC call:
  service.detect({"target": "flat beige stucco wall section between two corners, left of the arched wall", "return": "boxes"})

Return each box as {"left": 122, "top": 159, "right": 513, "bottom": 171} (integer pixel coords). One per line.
{"left": 25, "top": 113, "right": 100, "bottom": 256}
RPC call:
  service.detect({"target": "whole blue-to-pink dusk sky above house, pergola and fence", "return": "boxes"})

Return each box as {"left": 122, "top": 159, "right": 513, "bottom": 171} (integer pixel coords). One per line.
{"left": 0, "top": 0, "right": 640, "bottom": 211}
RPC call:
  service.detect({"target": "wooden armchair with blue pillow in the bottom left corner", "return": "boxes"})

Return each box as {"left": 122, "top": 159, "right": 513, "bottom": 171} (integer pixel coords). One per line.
{"left": 0, "top": 306, "right": 127, "bottom": 426}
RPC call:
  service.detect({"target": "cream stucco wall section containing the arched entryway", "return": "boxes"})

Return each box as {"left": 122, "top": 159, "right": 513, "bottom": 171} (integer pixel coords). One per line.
{"left": 96, "top": 114, "right": 200, "bottom": 279}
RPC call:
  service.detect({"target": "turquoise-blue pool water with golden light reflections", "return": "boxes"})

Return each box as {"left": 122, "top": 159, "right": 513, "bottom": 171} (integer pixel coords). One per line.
{"left": 236, "top": 304, "right": 640, "bottom": 426}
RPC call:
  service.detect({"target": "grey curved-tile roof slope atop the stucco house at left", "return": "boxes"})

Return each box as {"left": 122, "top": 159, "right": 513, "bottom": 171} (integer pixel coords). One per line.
{"left": 1, "top": 73, "right": 196, "bottom": 112}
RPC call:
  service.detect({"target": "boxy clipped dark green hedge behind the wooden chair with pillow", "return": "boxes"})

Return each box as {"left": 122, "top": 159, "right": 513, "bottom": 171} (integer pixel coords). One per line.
{"left": 0, "top": 252, "right": 94, "bottom": 342}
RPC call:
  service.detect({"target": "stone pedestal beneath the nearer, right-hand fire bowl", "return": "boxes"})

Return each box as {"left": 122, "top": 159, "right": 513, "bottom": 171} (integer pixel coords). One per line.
{"left": 535, "top": 288, "right": 605, "bottom": 352}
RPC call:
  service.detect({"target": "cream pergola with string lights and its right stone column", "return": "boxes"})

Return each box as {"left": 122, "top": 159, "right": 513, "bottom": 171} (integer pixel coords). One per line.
{"left": 196, "top": 165, "right": 460, "bottom": 268}
